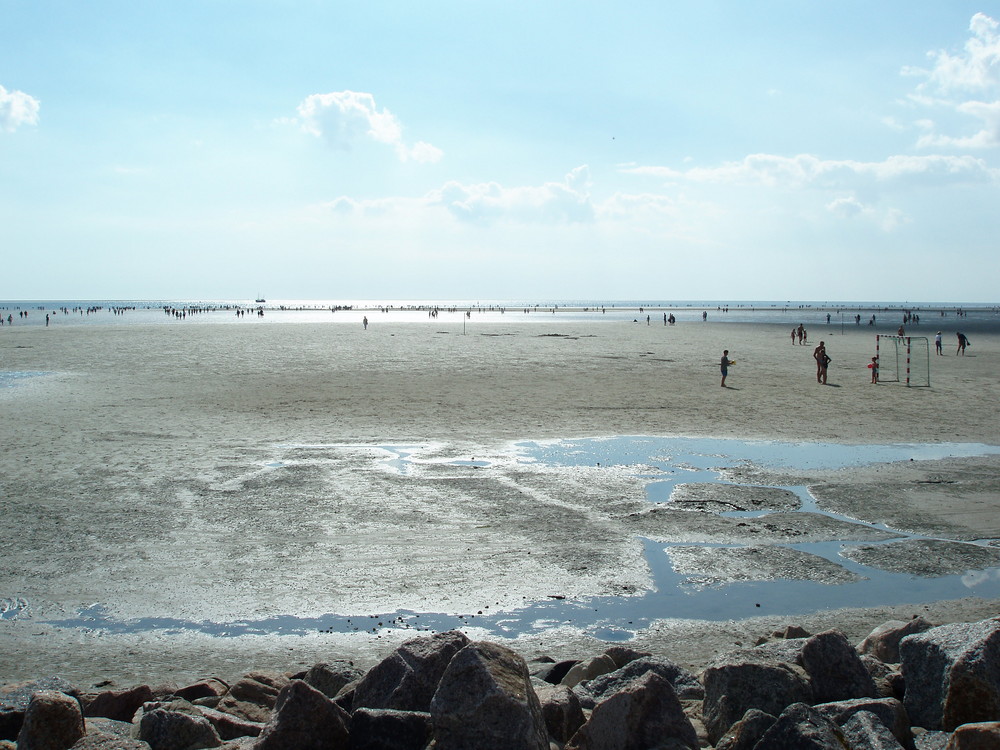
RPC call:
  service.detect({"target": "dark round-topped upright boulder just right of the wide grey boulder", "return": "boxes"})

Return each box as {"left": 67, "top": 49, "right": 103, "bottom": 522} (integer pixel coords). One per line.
{"left": 802, "top": 630, "right": 878, "bottom": 703}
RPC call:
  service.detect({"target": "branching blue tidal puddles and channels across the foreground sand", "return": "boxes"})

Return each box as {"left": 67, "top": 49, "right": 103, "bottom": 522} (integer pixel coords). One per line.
{"left": 35, "top": 436, "right": 1000, "bottom": 641}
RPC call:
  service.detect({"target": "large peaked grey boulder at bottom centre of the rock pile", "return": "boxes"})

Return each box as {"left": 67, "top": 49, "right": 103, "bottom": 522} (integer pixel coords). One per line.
{"left": 430, "top": 642, "right": 549, "bottom": 750}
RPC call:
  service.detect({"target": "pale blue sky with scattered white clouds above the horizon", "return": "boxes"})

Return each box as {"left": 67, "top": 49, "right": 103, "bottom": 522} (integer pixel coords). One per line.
{"left": 0, "top": 0, "right": 1000, "bottom": 304}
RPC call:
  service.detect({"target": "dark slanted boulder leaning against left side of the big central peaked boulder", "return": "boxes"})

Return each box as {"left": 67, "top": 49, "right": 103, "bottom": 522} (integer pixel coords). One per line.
{"left": 352, "top": 630, "right": 469, "bottom": 711}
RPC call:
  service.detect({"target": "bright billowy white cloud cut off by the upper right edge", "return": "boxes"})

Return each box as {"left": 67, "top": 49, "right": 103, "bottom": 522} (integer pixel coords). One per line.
{"left": 903, "top": 13, "right": 1000, "bottom": 149}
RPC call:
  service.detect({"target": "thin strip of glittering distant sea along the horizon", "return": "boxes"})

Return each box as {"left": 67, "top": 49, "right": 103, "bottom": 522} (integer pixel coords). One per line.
{"left": 0, "top": 299, "right": 1000, "bottom": 335}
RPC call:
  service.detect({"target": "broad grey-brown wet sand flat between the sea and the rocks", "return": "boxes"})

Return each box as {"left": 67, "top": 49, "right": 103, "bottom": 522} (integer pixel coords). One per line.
{"left": 0, "top": 313, "right": 1000, "bottom": 684}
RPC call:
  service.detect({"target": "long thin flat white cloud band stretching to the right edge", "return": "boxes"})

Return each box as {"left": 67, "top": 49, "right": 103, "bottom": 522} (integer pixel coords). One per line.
{"left": 622, "top": 154, "right": 998, "bottom": 189}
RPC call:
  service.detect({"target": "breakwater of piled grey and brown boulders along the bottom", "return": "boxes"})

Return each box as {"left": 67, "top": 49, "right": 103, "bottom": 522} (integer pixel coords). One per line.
{"left": 0, "top": 617, "right": 1000, "bottom": 750}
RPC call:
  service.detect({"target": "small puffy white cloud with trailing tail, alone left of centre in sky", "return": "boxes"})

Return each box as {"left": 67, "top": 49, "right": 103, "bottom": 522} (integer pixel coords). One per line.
{"left": 298, "top": 91, "right": 443, "bottom": 162}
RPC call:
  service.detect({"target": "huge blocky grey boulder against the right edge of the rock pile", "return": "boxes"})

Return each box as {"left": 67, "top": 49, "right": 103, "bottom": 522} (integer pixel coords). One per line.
{"left": 899, "top": 618, "right": 1000, "bottom": 731}
